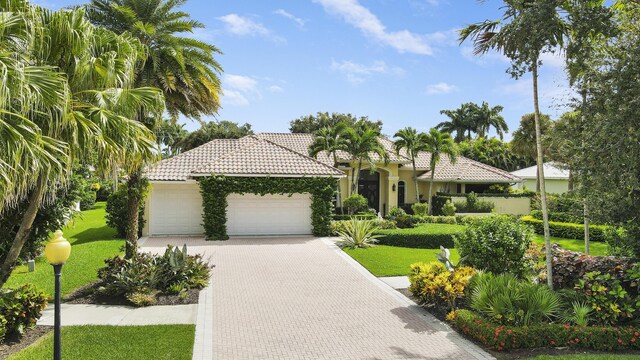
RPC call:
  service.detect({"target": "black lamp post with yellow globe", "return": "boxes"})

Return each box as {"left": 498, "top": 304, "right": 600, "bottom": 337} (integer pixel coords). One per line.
{"left": 44, "top": 230, "right": 71, "bottom": 360}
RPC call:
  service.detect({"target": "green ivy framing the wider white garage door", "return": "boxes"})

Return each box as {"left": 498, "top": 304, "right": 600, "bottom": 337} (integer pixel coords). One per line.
{"left": 198, "top": 175, "right": 337, "bottom": 240}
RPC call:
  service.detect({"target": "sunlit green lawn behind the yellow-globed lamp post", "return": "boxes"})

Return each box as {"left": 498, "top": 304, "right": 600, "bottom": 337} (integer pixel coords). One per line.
{"left": 5, "top": 202, "right": 124, "bottom": 297}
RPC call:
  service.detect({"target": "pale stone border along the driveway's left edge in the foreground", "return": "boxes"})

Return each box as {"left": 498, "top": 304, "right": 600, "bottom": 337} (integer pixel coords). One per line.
{"left": 192, "top": 276, "right": 213, "bottom": 360}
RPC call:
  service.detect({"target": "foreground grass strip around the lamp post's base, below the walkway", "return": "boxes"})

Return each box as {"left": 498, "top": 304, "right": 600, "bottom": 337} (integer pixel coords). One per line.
{"left": 9, "top": 325, "right": 195, "bottom": 360}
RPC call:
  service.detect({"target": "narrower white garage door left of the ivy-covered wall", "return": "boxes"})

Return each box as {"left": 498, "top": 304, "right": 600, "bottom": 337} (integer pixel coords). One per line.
{"left": 149, "top": 182, "right": 204, "bottom": 235}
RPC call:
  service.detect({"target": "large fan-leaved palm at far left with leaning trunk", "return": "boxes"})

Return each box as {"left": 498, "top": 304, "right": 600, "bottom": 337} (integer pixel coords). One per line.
{"left": 0, "top": 2, "right": 164, "bottom": 286}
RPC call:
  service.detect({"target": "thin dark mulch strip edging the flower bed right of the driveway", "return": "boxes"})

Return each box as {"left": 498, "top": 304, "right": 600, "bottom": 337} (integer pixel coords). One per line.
{"left": 397, "top": 289, "right": 640, "bottom": 360}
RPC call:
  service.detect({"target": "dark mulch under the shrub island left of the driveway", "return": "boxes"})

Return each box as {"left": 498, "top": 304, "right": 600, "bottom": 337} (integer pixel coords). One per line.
{"left": 64, "top": 282, "right": 200, "bottom": 306}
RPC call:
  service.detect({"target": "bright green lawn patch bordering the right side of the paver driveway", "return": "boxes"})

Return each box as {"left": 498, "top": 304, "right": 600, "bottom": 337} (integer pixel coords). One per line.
{"left": 344, "top": 245, "right": 460, "bottom": 276}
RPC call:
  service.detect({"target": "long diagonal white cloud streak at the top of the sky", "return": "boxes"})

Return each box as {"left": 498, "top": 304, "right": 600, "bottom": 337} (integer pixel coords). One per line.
{"left": 313, "top": 0, "right": 433, "bottom": 55}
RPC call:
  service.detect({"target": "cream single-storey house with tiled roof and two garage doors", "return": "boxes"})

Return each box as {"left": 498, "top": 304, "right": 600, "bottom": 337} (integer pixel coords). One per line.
{"left": 143, "top": 133, "right": 521, "bottom": 235}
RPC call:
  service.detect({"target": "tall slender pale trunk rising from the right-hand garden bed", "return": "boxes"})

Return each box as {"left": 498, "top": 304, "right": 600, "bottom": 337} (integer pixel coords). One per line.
{"left": 532, "top": 63, "right": 553, "bottom": 290}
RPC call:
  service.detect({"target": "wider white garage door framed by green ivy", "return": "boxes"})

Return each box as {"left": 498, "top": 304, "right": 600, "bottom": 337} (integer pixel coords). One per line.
{"left": 227, "top": 194, "right": 311, "bottom": 235}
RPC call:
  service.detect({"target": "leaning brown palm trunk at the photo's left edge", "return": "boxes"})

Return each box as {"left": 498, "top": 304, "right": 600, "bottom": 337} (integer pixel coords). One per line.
{"left": 0, "top": 175, "right": 47, "bottom": 288}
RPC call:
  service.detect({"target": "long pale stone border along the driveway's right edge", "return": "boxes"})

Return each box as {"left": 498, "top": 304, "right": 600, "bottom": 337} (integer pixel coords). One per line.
{"left": 321, "top": 238, "right": 495, "bottom": 360}
